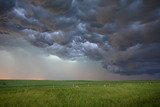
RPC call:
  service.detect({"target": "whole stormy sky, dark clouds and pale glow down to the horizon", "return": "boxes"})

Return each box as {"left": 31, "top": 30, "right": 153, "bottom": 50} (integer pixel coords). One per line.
{"left": 0, "top": 0, "right": 160, "bottom": 80}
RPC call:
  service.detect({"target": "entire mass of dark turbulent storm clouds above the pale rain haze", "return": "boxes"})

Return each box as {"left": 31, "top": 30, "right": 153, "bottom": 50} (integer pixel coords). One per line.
{"left": 0, "top": 0, "right": 160, "bottom": 75}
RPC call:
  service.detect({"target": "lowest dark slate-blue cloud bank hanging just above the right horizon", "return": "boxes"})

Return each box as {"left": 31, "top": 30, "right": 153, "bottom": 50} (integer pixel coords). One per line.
{"left": 104, "top": 43, "right": 160, "bottom": 74}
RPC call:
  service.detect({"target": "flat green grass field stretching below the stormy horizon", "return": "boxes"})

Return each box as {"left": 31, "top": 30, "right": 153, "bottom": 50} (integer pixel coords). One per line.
{"left": 0, "top": 80, "right": 160, "bottom": 107}
